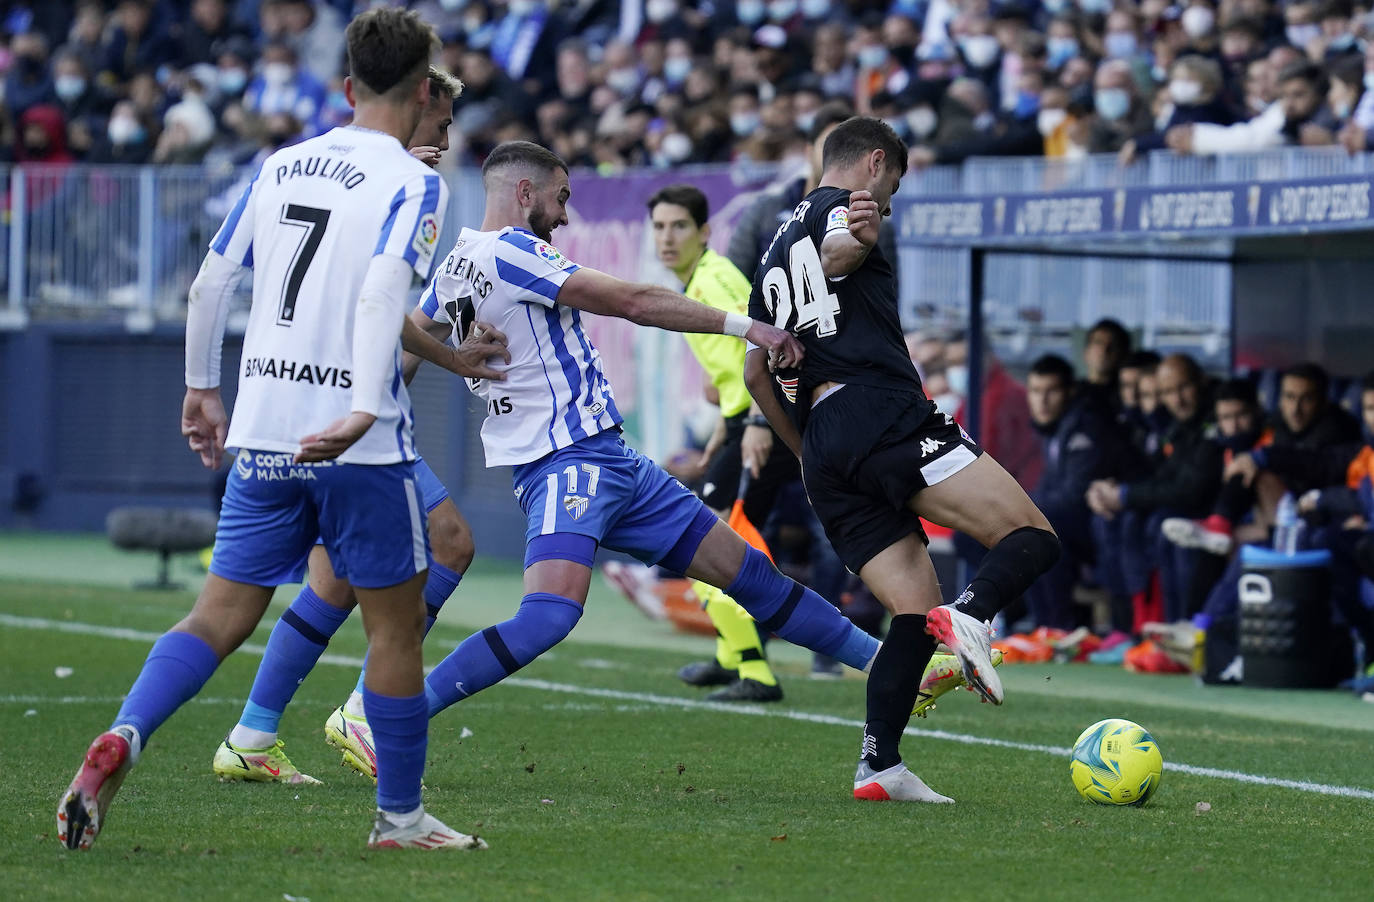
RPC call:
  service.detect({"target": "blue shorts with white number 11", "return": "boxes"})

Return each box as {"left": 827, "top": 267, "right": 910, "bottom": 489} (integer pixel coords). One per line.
{"left": 514, "top": 432, "right": 706, "bottom": 564}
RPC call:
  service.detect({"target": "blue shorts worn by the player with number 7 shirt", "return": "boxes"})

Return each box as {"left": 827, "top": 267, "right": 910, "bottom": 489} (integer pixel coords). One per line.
{"left": 210, "top": 451, "right": 429, "bottom": 589}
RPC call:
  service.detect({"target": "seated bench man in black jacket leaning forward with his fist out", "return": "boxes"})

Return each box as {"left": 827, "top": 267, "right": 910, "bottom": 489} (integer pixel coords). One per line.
{"left": 1087, "top": 353, "right": 1221, "bottom": 633}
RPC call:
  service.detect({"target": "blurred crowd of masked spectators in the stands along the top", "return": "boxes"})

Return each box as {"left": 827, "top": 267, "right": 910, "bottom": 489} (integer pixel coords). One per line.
{"left": 0, "top": 0, "right": 1374, "bottom": 171}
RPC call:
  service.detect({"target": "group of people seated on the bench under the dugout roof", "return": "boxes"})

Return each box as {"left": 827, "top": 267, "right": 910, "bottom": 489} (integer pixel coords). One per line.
{"left": 908, "top": 325, "right": 1374, "bottom": 690}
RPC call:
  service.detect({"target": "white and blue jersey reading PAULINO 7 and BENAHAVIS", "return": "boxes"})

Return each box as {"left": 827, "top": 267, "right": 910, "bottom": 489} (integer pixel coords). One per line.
{"left": 210, "top": 128, "right": 448, "bottom": 463}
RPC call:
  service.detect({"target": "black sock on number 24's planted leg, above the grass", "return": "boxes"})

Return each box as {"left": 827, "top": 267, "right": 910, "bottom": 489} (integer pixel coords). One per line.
{"left": 861, "top": 613, "right": 936, "bottom": 770}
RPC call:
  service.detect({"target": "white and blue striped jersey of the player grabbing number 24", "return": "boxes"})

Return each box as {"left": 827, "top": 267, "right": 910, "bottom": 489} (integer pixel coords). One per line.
{"left": 420, "top": 228, "right": 622, "bottom": 466}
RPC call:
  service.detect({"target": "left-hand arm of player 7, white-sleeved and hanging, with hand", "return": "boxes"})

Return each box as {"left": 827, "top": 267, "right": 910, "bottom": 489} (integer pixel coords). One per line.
{"left": 181, "top": 250, "right": 247, "bottom": 469}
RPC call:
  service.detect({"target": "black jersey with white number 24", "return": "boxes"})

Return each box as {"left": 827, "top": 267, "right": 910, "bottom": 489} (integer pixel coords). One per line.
{"left": 749, "top": 187, "right": 925, "bottom": 425}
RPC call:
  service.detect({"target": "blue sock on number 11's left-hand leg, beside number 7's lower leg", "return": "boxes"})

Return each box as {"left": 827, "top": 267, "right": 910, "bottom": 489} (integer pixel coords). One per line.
{"left": 425, "top": 593, "right": 583, "bottom": 716}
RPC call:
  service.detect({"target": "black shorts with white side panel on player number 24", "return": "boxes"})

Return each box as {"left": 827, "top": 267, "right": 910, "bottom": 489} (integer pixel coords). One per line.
{"left": 801, "top": 385, "right": 982, "bottom": 573}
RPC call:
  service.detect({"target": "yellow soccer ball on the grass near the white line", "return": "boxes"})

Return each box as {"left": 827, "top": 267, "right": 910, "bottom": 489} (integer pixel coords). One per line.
{"left": 1069, "top": 718, "right": 1164, "bottom": 807}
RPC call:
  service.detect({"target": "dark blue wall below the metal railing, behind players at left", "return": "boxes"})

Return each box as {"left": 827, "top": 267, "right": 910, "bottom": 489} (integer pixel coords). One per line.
{"left": 0, "top": 323, "right": 523, "bottom": 557}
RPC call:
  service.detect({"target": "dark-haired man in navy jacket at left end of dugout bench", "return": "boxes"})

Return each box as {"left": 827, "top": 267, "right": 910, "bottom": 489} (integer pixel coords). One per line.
{"left": 1025, "top": 353, "right": 1120, "bottom": 630}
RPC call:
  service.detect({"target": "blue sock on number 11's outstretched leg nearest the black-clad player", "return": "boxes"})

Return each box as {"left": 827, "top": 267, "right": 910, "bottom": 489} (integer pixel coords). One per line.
{"left": 725, "top": 547, "right": 878, "bottom": 670}
